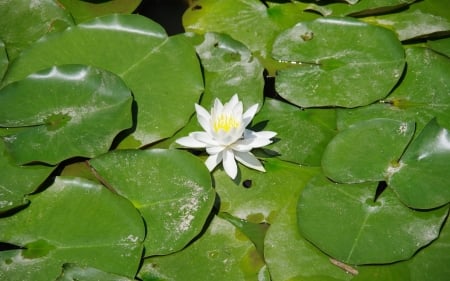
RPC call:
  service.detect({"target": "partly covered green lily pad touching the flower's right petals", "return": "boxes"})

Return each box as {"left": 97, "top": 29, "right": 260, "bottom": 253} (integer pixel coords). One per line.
{"left": 253, "top": 98, "right": 336, "bottom": 166}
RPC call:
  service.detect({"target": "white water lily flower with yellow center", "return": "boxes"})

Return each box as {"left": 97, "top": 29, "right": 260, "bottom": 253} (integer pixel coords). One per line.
{"left": 176, "top": 94, "right": 276, "bottom": 179}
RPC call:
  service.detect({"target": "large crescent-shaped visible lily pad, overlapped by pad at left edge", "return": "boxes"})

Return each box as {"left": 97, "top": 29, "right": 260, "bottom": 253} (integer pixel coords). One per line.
{"left": 5, "top": 14, "right": 203, "bottom": 148}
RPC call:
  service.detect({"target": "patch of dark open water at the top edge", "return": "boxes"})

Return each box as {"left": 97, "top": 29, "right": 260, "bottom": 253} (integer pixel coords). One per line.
{"left": 136, "top": 0, "right": 188, "bottom": 35}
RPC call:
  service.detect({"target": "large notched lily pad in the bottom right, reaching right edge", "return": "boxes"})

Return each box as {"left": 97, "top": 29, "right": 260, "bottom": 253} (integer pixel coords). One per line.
{"left": 297, "top": 176, "right": 449, "bottom": 264}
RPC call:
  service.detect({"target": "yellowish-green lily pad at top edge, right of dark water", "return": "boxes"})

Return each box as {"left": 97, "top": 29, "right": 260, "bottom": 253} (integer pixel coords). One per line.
{"left": 183, "top": 0, "right": 317, "bottom": 68}
